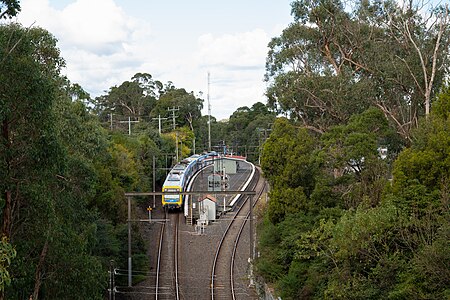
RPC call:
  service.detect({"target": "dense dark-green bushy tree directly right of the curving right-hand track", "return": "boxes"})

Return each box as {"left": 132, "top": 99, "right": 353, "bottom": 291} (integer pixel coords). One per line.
{"left": 261, "top": 119, "right": 317, "bottom": 224}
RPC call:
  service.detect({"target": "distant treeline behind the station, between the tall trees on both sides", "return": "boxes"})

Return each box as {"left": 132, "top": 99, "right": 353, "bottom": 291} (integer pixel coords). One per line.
{"left": 89, "top": 73, "right": 276, "bottom": 161}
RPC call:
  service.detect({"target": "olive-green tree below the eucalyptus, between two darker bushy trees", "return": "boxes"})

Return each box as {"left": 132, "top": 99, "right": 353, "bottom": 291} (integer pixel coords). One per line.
{"left": 312, "top": 108, "right": 397, "bottom": 208}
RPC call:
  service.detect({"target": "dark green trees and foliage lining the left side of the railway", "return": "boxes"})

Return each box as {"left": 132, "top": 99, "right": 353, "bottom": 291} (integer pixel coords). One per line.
{"left": 0, "top": 24, "right": 162, "bottom": 299}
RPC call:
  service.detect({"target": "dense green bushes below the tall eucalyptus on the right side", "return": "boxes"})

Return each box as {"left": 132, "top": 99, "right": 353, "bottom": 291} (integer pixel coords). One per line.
{"left": 257, "top": 88, "right": 450, "bottom": 299}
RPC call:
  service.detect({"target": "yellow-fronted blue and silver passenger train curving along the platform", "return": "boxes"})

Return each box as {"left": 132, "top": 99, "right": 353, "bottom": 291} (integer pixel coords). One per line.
{"left": 162, "top": 152, "right": 217, "bottom": 210}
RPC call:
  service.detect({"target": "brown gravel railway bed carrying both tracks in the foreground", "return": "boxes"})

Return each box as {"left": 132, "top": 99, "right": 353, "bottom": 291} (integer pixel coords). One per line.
{"left": 123, "top": 161, "right": 261, "bottom": 300}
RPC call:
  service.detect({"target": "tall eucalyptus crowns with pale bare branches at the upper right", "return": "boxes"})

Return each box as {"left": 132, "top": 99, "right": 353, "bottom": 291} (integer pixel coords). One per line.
{"left": 266, "top": 0, "right": 450, "bottom": 140}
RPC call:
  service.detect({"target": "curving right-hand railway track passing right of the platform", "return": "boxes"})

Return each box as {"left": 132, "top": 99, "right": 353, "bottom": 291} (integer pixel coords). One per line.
{"left": 210, "top": 165, "right": 265, "bottom": 300}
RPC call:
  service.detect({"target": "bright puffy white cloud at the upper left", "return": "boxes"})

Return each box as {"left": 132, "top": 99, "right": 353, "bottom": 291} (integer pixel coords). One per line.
{"left": 20, "top": 0, "right": 148, "bottom": 54}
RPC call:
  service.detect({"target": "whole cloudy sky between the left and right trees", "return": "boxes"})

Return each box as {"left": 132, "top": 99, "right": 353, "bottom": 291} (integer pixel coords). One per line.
{"left": 12, "top": 0, "right": 293, "bottom": 120}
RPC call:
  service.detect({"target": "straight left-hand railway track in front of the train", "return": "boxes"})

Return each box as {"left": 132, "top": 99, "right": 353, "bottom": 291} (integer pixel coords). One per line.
{"left": 155, "top": 211, "right": 180, "bottom": 300}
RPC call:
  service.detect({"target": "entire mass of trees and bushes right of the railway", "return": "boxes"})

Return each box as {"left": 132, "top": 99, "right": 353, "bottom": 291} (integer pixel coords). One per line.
{"left": 256, "top": 0, "right": 450, "bottom": 299}
